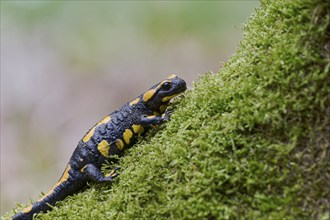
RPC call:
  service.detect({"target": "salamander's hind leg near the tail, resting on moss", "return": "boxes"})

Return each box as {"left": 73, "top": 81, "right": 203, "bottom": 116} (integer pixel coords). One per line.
{"left": 81, "top": 164, "right": 119, "bottom": 182}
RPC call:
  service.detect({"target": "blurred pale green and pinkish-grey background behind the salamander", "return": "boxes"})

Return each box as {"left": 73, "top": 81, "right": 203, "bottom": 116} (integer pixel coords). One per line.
{"left": 1, "top": 1, "right": 259, "bottom": 214}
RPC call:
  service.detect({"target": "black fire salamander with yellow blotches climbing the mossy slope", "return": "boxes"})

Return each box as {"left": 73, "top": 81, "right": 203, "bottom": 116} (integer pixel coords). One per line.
{"left": 13, "top": 75, "right": 187, "bottom": 220}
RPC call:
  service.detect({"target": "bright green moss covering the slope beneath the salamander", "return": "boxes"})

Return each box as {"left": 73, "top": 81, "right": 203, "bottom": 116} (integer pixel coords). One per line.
{"left": 3, "top": 0, "right": 330, "bottom": 219}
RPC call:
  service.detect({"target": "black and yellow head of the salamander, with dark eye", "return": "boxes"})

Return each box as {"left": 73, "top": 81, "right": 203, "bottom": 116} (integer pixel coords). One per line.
{"left": 142, "top": 75, "right": 187, "bottom": 113}
